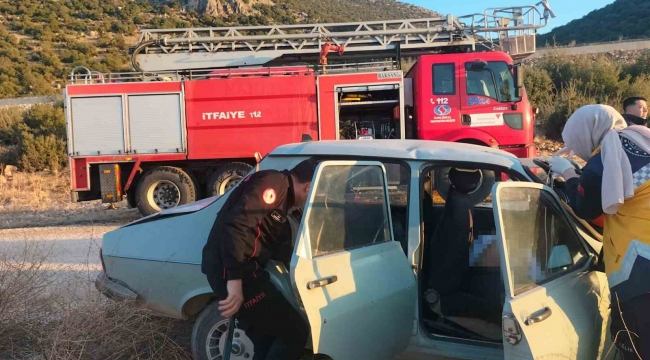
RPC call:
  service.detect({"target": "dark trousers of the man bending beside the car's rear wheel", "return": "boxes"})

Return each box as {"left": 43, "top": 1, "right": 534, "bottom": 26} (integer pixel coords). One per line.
{"left": 208, "top": 278, "right": 309, "bottom": 360}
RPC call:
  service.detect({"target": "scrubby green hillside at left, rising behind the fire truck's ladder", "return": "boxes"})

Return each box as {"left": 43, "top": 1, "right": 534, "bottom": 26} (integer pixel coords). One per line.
{"left": 0, "top": 0, "right": 437, "bottom": 98}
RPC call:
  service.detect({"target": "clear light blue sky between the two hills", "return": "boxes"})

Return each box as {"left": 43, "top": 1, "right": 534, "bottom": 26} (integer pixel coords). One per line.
{"left": 402, "top": 0, "right": 614, "bottom": 34}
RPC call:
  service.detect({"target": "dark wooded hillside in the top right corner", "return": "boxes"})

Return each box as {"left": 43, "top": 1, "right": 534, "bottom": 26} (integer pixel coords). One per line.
{"left": 537, "top": 0, "right": 650, "bottom": 46}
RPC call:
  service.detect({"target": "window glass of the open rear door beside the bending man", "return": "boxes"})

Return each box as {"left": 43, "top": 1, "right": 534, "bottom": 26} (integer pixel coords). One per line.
{"left": 305, "top": 165, "right": 392, "bottom": 257}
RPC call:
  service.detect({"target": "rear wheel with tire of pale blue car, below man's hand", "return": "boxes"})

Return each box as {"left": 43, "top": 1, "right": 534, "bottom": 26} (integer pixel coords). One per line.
{"left": 191, "top": 301, "right": 255, "bottom": 360}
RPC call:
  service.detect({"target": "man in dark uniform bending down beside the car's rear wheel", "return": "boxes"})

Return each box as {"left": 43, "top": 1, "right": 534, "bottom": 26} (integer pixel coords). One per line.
{"left": 201, "top": 159, "right": 318, "bottom": 360}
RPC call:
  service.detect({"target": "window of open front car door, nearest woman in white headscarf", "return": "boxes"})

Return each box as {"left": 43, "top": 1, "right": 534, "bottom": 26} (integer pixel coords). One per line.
{"left": 498, "top": 187, "right": 587, "bottom": 296}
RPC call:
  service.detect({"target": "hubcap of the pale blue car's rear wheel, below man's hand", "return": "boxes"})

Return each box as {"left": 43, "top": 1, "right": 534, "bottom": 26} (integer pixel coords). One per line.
{"left": 205, "top": 319, "right": 255, "bottom": 360}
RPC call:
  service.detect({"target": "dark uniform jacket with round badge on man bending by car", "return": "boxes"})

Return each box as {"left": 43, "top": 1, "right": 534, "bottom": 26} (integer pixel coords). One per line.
{"left": 201, "top": 170, "right": 294, "bottom": 296}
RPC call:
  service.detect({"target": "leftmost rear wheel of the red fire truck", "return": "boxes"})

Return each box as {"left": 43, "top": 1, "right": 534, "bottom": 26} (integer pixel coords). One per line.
{"left": 135, "top": 166, "right": 198, "bottom": 216}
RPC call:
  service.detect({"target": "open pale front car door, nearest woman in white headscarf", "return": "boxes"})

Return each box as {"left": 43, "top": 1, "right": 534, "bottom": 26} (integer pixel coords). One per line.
{"left": 492, "top": 182, "right": 609, "bottom": 360}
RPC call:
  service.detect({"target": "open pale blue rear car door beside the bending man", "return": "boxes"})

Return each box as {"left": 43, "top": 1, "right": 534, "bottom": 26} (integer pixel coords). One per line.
{"left": 291, "top": 161, "right": 417, "bottom": 360}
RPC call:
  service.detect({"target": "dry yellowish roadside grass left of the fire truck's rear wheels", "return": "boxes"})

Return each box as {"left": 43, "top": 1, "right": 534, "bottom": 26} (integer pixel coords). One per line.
{"left": 0, "top": 169, "right": 140, "bottom": 229}
